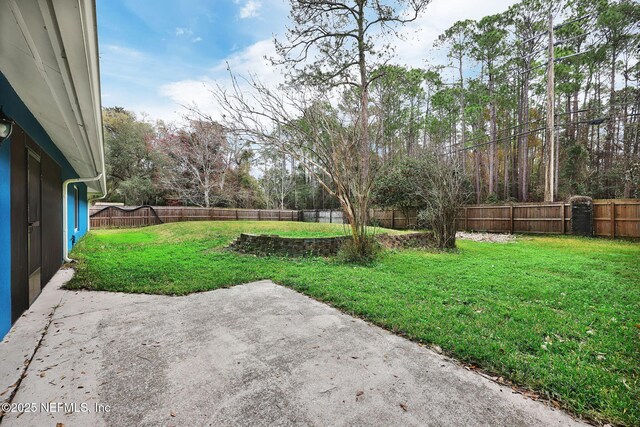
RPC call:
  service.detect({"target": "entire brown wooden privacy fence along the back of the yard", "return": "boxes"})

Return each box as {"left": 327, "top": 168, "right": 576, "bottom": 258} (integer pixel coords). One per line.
{"left": 90, "top": 199, "right": 640, "bottom": 238}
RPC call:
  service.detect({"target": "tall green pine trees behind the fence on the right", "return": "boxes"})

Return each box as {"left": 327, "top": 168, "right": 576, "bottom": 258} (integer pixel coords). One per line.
{"left": 267, "top": 0, "right": 640, "bottom": 206}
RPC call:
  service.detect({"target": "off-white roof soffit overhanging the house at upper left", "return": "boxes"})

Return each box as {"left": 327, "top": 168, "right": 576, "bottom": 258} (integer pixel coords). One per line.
{"left": 0, "top": 0, "right": 106, "bottom": 192}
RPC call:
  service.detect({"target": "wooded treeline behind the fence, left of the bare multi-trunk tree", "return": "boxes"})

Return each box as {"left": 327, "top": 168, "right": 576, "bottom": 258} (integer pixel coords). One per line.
{"left": 103, "top": 107, "right": 338, "bottom": 209}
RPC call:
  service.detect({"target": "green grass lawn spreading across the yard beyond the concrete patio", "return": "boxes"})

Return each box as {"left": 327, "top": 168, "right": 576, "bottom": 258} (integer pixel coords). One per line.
{"left": 68, "top": 222, "right": 640, "bottom": 425}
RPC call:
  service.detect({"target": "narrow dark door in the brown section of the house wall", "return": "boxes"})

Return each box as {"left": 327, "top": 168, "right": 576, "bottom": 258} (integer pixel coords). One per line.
{"left": 27, "top": 149, "right": 42, "bottom": 305}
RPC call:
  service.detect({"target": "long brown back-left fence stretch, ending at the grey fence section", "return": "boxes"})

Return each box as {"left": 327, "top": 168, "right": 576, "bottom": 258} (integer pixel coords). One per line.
{"left": 89, "top": 206, "right": 300, "bottom": 228}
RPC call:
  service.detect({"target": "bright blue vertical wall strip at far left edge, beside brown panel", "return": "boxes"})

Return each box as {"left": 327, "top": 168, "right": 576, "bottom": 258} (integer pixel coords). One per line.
{"left": 0, "top": 141, "right": 11, "bottom": 339}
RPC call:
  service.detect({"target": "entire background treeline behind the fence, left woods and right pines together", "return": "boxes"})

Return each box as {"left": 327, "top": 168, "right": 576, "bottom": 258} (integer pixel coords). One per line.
{"left": 104, "top": 0, "right": 640, "bottom": 209}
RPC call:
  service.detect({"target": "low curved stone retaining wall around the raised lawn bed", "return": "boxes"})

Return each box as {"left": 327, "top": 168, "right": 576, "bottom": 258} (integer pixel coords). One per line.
{"left": 229, "top": 233, "right": 433, "bottom": 257}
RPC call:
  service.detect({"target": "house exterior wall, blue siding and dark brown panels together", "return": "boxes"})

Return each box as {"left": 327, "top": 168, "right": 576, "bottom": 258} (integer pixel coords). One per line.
{"left": 0, "top": 73, "right": 88, "bottom": 339}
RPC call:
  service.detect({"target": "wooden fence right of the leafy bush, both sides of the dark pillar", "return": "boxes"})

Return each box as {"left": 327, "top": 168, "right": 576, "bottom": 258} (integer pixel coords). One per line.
{"left": 456, "top": 199, "right": 640, "bottom": 238}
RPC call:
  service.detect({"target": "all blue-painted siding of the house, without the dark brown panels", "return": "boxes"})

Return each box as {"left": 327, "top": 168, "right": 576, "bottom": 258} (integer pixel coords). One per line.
{"left": 0, "top": 73, "right": 88, "bottom": 339}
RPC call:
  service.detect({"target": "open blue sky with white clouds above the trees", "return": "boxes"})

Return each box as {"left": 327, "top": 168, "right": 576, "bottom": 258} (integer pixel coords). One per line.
{"left": 97, "top": 0, "right": 514, "bottom": 120}
